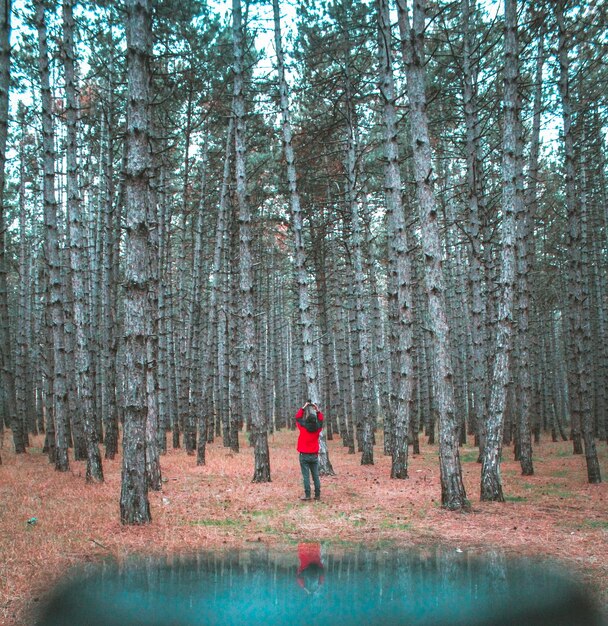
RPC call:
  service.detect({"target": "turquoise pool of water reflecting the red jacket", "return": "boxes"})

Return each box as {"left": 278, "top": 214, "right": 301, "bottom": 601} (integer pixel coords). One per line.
{"left": 36, "top": 543, "right": 606, "bottom": 626}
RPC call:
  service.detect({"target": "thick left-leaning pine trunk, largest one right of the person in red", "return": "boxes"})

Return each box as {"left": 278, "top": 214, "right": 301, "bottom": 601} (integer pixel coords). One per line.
{"left": 397, "top": 0, "right": 469, "bottom": 510}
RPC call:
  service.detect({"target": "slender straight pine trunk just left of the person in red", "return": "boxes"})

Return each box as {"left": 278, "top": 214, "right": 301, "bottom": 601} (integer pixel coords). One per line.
{"left": 232, "top": 0, "right": 270, "bottom": 483}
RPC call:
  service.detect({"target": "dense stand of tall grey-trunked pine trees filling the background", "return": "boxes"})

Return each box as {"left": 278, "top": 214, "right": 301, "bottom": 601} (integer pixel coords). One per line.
{"left": 0, "top": 0, "right": 608, "bottom": 525}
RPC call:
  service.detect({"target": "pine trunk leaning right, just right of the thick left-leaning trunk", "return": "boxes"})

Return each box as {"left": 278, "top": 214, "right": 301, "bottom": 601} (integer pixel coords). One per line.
{"left": 481, "top": 0, "right": 520, "bottom": 502}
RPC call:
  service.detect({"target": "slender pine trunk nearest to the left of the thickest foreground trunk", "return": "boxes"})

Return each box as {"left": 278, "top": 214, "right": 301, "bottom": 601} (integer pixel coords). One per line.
{"left": 62, "top": 0, "right": 103, "bottom": 482}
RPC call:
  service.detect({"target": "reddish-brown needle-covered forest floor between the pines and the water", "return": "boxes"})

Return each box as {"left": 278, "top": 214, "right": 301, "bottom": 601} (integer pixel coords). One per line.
{"left": 0, "top": 431, "right": 608, "bottom": 626}
